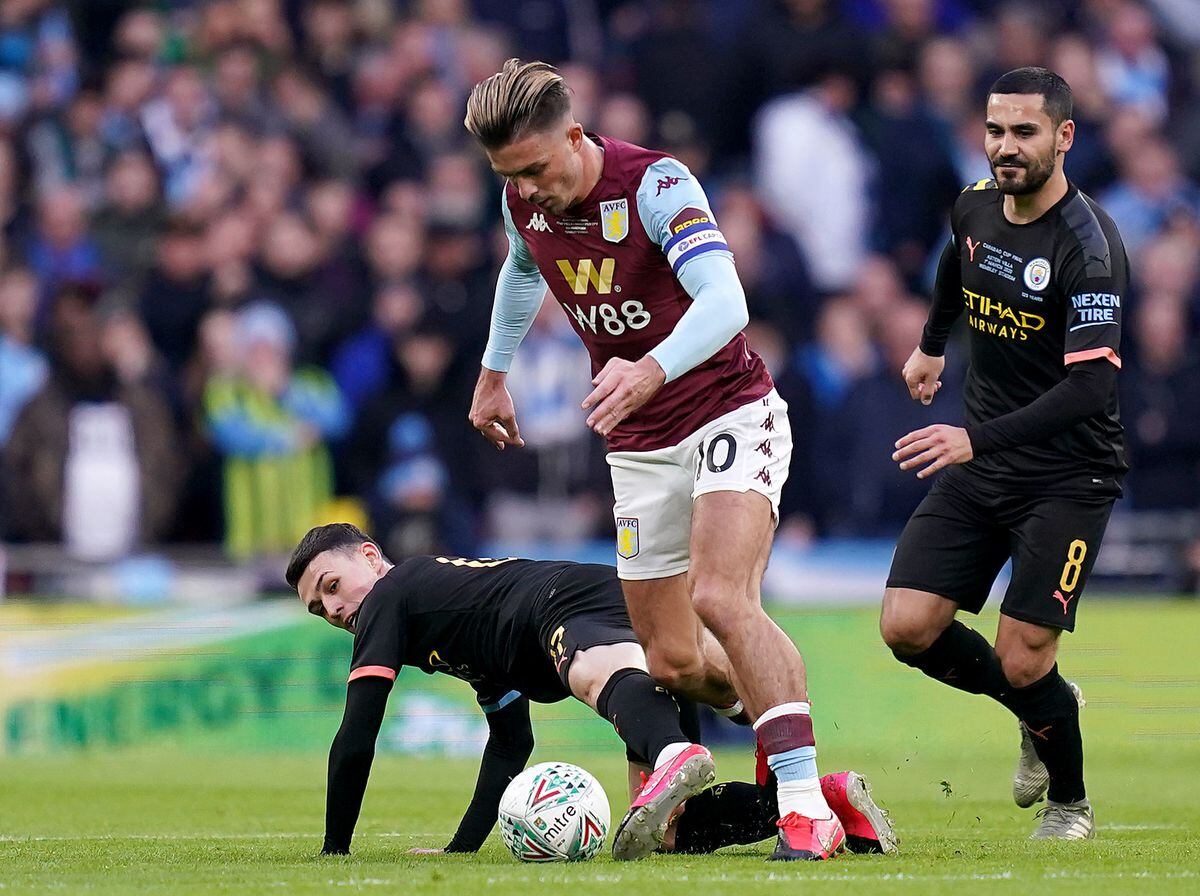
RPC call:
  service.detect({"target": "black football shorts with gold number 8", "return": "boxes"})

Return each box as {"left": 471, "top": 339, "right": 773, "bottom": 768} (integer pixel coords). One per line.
{"left": 888, "top": 469, "right": 1116, "bottom": 631}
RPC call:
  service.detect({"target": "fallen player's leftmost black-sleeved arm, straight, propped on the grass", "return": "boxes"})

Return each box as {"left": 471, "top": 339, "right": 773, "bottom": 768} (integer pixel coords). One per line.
{"left": 320, "top": 675, "right": 392, "bottom": 855}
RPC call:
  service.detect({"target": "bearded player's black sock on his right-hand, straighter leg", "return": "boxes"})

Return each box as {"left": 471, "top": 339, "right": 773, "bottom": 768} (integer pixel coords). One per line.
{"left": 1004, "top": 663, "right": 1087, "bottom": 802}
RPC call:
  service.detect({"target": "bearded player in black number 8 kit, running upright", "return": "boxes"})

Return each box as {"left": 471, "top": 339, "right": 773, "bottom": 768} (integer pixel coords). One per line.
{"left": 880, "top": 68, "right": 1128, "bottom": 840}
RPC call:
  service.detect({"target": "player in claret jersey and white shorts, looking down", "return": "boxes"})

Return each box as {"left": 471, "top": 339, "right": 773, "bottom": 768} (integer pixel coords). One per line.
{"left": 466, "top": 60, "right": 846, "bottom": 860}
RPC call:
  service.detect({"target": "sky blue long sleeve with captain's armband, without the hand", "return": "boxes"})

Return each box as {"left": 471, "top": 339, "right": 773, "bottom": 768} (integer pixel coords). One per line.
{"left": 637, "top": 158, "right": 750, "bottom": 383}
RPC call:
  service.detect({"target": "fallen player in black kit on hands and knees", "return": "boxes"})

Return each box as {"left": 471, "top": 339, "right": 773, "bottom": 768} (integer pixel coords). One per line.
{"left": 287, "top": 523, "right": 894, "bottom": 859}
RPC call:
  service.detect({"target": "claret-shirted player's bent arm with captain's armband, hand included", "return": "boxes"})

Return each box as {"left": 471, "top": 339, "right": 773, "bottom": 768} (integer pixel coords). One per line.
{"left": 583, "top": 158, "right": 750, "bottom": 435}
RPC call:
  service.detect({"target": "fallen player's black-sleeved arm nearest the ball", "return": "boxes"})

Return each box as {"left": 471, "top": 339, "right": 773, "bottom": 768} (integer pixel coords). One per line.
{"left": 445, "top": 691, "right": 533, "bottom": 853}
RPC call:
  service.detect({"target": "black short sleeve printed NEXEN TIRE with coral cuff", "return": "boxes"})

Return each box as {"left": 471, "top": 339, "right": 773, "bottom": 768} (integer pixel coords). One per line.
{"left": 1058, "top": 218, "right": 1129, "bottom": 369}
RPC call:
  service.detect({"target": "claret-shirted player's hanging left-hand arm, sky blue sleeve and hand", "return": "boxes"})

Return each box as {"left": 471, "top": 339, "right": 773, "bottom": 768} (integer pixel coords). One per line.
{"left": 469, "top": 196, "right": 546, "bottom": 451}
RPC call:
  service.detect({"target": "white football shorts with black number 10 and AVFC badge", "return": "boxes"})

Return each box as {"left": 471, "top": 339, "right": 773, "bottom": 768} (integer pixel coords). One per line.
{"left": 608, "top": 389, "right": 792, "bottom": 579}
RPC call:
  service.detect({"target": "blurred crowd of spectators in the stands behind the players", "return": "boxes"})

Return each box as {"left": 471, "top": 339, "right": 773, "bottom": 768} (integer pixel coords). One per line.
{"left": 0, "top": 0, "right": 1200, "bottom": 568}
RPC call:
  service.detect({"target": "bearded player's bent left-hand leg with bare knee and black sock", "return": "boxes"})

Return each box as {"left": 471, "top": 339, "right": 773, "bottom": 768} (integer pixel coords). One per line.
{"left": 880, "top": 474, "right": 1009, "bottom": 702}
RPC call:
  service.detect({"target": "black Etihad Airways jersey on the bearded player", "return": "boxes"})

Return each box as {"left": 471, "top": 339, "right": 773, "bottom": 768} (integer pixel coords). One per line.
{"left": 937, "top": 180, "right": 1129, "bottom": 494}
